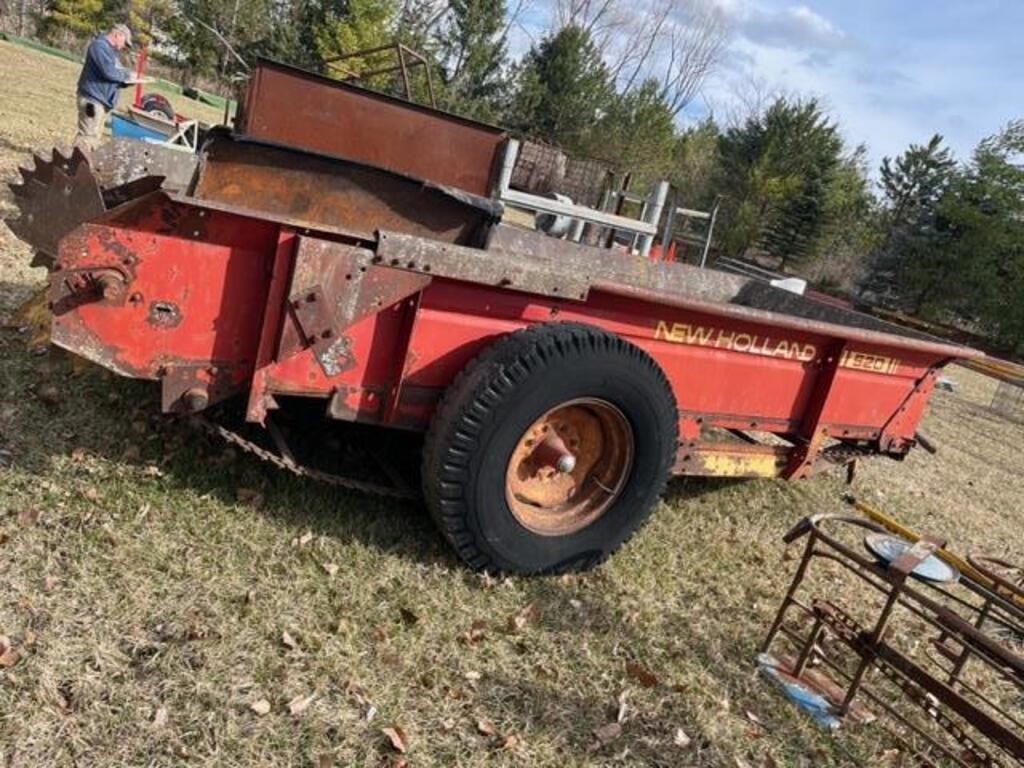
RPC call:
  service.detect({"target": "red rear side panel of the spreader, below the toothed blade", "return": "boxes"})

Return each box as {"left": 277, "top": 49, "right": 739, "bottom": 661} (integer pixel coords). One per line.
{"left": 50, "top": 194, "right": 276, "bottom": 411}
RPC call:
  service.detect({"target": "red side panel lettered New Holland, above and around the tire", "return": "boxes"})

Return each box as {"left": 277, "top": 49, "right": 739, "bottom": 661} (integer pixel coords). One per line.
{"left": 385, "top": 281, "right": 942, "bottom": 440}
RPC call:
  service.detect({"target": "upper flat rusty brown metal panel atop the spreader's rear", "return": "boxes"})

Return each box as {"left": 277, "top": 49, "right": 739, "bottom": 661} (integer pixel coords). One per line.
{"left": 236, "top": 59, "right": 505, "bottom": 195}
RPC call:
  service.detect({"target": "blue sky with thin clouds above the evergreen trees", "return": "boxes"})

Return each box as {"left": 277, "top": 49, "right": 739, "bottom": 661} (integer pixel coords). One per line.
{"left": 510, "top": 0, "right": 1024, "bottom": 171}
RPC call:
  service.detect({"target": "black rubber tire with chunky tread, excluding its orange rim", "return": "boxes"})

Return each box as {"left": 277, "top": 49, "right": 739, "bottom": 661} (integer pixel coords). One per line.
{"left": 423, "top": 323, "right": 678, "bottom": 573}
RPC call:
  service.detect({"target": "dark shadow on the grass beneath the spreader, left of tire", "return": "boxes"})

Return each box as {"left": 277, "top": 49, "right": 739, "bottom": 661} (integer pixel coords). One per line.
{"left": 0, "top": 329, "right": 459, "bottom": 568}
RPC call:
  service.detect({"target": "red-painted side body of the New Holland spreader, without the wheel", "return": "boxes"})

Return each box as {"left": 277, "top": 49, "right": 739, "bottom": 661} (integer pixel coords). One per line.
{"left": 51, "top": 194, "right": 974, "bottom": 477}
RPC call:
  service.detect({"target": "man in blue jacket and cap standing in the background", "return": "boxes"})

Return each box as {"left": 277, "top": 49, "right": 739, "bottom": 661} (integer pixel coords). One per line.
{"left": 75, "top": 24, "right": 150, "bottom": 155}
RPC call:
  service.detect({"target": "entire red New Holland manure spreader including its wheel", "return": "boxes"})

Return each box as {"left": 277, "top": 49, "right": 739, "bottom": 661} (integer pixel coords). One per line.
{"left": 8, "top": 61, "right": 979, "bottom": 573}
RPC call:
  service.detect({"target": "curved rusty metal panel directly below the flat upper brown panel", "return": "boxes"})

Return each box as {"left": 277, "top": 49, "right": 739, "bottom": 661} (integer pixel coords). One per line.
{"left": 195, "top": 136, "right": 489, "bottom": 243}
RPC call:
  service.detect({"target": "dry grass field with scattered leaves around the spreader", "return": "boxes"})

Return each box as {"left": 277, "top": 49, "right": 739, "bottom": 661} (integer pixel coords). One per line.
{"left": 0, "top": 43, "right": 1024, "bottom": 768}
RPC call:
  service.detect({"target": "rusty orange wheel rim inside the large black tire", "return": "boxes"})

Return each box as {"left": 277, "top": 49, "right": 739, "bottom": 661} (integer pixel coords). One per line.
{"left": 505, "top": 398, "right": 634, "bottom": 536}
